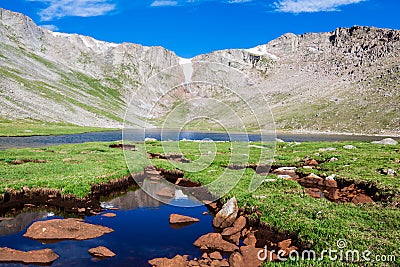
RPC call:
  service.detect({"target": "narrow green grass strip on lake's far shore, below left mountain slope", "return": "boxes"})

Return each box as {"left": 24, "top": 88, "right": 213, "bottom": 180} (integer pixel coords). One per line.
{"left": 0, "top": 120, "right": 117, "bottom": 136}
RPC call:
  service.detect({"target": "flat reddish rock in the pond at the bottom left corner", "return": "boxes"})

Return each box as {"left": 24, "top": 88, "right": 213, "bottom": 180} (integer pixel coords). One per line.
{"left": 0, "top": 247, "right": 58, "bottom": 264}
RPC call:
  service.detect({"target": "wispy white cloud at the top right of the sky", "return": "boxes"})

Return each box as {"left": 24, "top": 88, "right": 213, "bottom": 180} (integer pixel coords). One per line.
{"left": 274, "top": 0, "right": 366, "bottom": 13}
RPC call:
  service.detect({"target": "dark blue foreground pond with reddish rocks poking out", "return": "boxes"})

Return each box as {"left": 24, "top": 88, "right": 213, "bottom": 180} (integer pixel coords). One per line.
{"left": 0, "top": 177, "right": 213, "bottom": 266}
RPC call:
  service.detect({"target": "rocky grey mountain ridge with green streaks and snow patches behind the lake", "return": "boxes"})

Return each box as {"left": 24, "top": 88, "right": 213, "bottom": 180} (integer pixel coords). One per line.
{"left": 0, "top": 9, "right": 400, "bottom": 134}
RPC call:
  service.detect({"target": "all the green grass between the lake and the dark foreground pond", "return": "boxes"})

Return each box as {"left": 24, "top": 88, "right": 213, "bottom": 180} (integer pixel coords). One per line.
{"left": 0, "top": 141, "right": 400, "bottom": 266}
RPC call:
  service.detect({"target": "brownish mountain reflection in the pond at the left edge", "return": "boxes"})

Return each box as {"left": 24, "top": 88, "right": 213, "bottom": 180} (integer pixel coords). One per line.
{"left": 0, "top": 211, "right": 48, "bottom": 236}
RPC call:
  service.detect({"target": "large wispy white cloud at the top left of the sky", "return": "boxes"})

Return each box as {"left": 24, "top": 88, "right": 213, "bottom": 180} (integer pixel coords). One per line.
{"left": 29, "top": 0, "right": 115, "bottom": 21}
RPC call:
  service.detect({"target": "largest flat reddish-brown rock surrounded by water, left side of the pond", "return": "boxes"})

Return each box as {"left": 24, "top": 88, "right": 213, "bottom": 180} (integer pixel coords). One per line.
{"left": 24, "top": 218, "right": 114, "bottom": 240}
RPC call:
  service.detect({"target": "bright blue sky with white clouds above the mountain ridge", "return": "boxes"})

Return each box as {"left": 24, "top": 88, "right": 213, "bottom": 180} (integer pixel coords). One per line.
{"left": 0, "top": 0, "right": 400, "bottom": 57}
